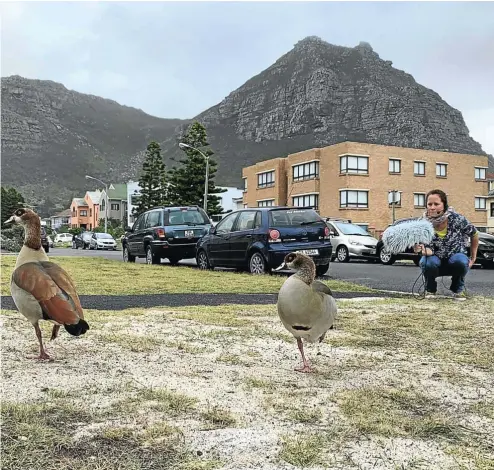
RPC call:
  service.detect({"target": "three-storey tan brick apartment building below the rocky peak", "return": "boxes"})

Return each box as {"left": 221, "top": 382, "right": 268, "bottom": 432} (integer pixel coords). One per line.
{"left": 242, "top": 142, "right": 488, "bottom": 232}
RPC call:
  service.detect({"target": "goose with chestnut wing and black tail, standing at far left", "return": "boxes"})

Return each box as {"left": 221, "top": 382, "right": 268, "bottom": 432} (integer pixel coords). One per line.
{"left": 5, "top": 209, "right": 89, "bottom": 359}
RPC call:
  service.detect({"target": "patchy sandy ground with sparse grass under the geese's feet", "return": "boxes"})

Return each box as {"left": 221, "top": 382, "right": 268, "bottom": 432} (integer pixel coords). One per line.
{"left": 1, "top": 298, "right": 494, "bottom": 470}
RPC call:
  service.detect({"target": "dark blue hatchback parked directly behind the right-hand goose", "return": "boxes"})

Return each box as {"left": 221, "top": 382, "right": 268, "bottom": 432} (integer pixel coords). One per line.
{"left": 196, "top": 207, "right": 332, "bottom": 276}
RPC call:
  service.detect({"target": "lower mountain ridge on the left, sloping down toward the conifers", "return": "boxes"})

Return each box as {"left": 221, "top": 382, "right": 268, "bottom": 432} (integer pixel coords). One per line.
{"left": 1, "top": 76, "right": 187, "bottom": 215}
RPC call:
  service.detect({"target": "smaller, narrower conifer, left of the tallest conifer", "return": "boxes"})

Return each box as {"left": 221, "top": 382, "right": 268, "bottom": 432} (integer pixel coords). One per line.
{"left": 133, "top": 141, "right": 168, "bottom": 217}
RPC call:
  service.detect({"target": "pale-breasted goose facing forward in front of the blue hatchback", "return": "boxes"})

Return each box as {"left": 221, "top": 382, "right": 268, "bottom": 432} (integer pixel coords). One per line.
{"left": 275, "top": 253, "right": 338, "bottom": 372}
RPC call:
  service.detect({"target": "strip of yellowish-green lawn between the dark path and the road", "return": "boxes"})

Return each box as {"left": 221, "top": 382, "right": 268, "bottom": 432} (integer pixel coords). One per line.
{"left": 1, "top": 256, "right": 372, "bottom": 295}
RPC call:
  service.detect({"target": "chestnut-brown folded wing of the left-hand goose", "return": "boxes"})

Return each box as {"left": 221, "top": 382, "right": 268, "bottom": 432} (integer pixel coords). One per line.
{"left": 12, "top": 263, "right": 82, "bottom": 325}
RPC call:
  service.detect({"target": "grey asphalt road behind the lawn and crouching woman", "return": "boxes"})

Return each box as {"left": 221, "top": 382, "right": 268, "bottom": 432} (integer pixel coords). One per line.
{"left": 43, "top": 248, "right": 494, "bottom": 296}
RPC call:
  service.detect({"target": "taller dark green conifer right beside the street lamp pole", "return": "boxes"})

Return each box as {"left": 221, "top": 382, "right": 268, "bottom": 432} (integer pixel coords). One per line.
{"left": 169, "top": 121, "right": 226, "bottom": 216}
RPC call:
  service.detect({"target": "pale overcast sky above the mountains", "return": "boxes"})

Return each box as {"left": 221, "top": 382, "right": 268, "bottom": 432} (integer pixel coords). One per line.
{"left": 0, "top": 2, "right": 494, "bottom": 154}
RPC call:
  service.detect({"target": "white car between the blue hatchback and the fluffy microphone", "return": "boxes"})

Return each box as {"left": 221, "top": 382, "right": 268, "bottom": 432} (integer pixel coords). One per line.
{"left": 325, "top": 218, "right": 378, "bottom": 263}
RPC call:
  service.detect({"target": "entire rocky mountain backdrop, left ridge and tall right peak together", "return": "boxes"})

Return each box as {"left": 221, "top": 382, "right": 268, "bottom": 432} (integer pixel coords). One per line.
{"left": 2, "top": 37, "right": 494, "bottom": 216}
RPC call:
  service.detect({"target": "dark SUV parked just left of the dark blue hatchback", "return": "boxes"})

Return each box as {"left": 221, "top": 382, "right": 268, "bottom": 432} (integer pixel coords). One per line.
{"left": 122, "top": 206, "right": 211, "bottom": 265}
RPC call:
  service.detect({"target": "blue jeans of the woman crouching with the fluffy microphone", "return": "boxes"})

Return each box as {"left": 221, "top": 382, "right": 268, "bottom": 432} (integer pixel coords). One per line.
{"left": 419, "top": 253, "right": 469, "bottom": 293}
